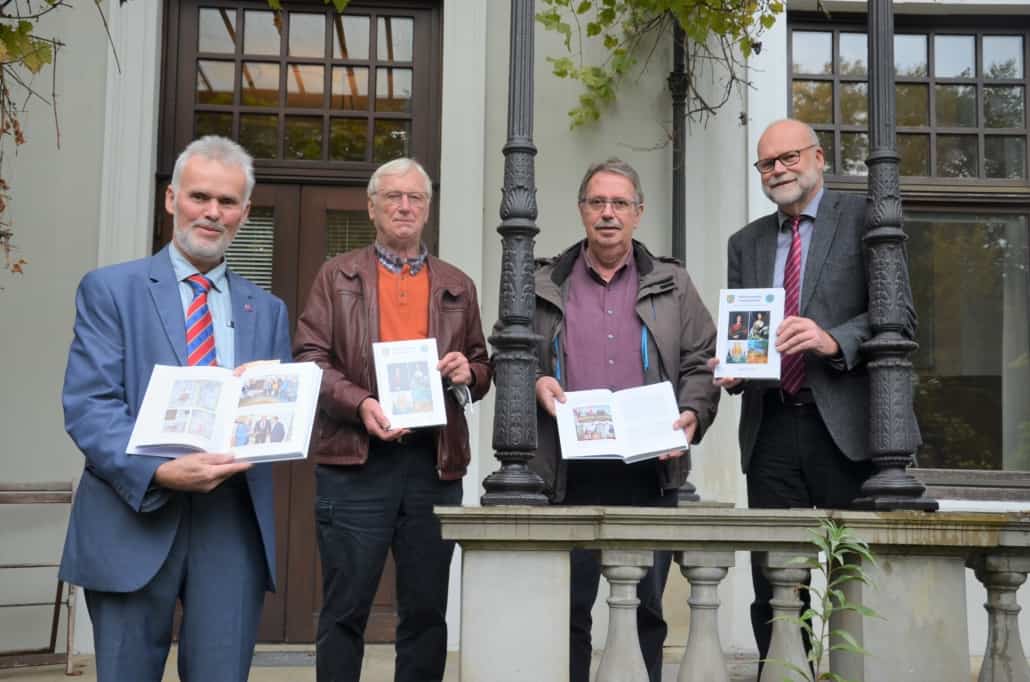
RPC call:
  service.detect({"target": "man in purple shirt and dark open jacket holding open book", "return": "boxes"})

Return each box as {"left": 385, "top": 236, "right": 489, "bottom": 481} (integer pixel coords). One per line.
{"left": 530, "top": 159, "right": 719, "bottom": 682}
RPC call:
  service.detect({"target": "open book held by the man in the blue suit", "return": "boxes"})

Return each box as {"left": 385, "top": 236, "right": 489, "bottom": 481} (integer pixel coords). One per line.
{"left": 128, "top": 363, "right": 321, "bottom": 462}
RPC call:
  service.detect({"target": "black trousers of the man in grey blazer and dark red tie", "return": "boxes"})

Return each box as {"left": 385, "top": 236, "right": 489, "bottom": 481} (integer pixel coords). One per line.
{"left": 748, "top": 389, "right": 873, "bottom": 673}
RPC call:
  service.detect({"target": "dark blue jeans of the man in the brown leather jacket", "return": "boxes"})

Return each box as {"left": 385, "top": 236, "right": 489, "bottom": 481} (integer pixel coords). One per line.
{"left": 315, "top": 441, "right": 461, "bottom": 682}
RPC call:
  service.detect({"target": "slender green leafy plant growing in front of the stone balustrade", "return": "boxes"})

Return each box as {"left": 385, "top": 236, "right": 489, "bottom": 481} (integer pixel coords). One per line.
{"left": 774, "top": 519, "right": 881, "bottom": 682}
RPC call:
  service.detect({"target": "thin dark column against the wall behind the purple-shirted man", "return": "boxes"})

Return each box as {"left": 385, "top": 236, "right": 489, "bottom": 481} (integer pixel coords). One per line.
{"left": 668, "top": 24, "right": 700, "bottom": 502}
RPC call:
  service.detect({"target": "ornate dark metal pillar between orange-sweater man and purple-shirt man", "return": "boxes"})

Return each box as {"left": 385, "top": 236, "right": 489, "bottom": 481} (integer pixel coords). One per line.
{"left": 482, "top": 0, "right": 547, "bottom": 506}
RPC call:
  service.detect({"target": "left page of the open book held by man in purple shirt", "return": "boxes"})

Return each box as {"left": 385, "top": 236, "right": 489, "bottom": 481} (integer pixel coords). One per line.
{"left": 554, "top": 389, "right": 622, "bottom": 459}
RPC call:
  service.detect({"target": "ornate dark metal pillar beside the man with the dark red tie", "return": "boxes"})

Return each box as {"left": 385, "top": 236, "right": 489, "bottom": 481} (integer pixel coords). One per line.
{"left": 854, "top": 0, "right": 937, "bottom": 511}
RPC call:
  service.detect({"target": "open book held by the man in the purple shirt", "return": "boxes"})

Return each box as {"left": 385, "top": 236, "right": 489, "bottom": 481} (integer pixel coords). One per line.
{"left": 554, "top": 381, "right": 689, "bottom": 464}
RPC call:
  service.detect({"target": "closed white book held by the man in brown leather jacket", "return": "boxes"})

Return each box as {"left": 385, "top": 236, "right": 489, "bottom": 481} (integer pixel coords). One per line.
{"left": 372, "top": 339, "right": 447, "bottom": 429}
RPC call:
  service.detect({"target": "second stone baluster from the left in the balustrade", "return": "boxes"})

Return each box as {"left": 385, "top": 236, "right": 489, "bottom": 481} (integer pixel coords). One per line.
{"left": 675, "top": 550, "right": 733, "bottom": 682}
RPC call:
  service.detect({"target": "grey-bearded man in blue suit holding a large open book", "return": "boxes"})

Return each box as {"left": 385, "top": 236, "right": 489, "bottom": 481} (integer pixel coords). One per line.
{"left": 61, "top": 136, "right": 290, "bottom": 682}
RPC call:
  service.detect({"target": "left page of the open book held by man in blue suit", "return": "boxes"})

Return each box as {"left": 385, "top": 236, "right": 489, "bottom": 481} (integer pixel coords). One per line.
{"left": 128, "top": 365, "right": 239, "bottom": 456}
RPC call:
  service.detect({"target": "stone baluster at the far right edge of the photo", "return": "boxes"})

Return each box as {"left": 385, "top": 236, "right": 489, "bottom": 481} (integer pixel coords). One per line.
{"left": 967, "top": 554, "right": 1030, "bottom": 682}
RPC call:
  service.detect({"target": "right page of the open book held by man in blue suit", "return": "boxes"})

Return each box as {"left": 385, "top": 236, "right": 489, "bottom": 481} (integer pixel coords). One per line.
{"left": 227, "top": 363, "right": 321, "bottom": 461}
